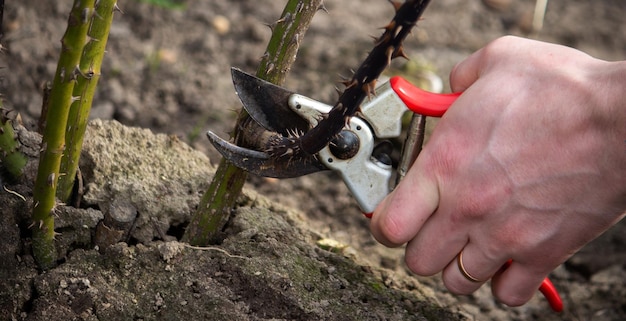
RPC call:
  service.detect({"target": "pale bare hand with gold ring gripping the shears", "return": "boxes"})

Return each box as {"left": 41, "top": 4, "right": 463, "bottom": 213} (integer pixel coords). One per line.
{"left": 371, "top": 36, "right": 626, "bottom": 306}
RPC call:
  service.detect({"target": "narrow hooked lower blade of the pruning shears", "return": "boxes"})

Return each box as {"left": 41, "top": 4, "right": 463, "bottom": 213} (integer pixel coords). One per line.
{"left": 207, "top": 131, "right": 327, "bottom": 178}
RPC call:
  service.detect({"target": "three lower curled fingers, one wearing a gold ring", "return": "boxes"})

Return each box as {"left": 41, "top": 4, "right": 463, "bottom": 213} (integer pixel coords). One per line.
{"left": 405, "top": 194, "right": 543, "bottom": 306}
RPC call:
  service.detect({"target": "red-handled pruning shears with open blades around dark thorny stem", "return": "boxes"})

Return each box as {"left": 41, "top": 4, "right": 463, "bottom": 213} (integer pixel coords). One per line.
{"left": 207, "top": 68, "right": 563, "bottom": 312}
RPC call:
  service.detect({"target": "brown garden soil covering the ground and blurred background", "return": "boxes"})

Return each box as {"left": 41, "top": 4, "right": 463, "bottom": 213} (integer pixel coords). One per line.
{"left": 0, "top": 0, "right": 626, "bottom": 320}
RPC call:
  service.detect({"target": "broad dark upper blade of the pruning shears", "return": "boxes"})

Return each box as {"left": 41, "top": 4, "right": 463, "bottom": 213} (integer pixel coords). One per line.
{"left": 231, "top": 67, "right": 309, "bottom": 135}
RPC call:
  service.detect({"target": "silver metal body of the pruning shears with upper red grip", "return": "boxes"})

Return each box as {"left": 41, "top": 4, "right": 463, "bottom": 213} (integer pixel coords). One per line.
{"left": 280, "top": 76, "right": 459, "bottom": 213}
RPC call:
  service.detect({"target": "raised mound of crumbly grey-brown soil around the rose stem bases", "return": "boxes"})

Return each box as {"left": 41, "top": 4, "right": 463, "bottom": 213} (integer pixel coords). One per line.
{"left": 0, "top": 121, "right": 462, "bottom": 321}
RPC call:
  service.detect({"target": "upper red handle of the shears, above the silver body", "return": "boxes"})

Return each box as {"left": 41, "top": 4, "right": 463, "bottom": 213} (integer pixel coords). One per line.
{"left": 389, "top": 76, "right": 461, "bottom": 117}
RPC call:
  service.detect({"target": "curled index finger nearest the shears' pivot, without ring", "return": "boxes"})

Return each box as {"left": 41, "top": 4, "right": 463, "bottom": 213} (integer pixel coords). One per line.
{"left": 370, "top": 157, "right": 439, "bottom": 246}
